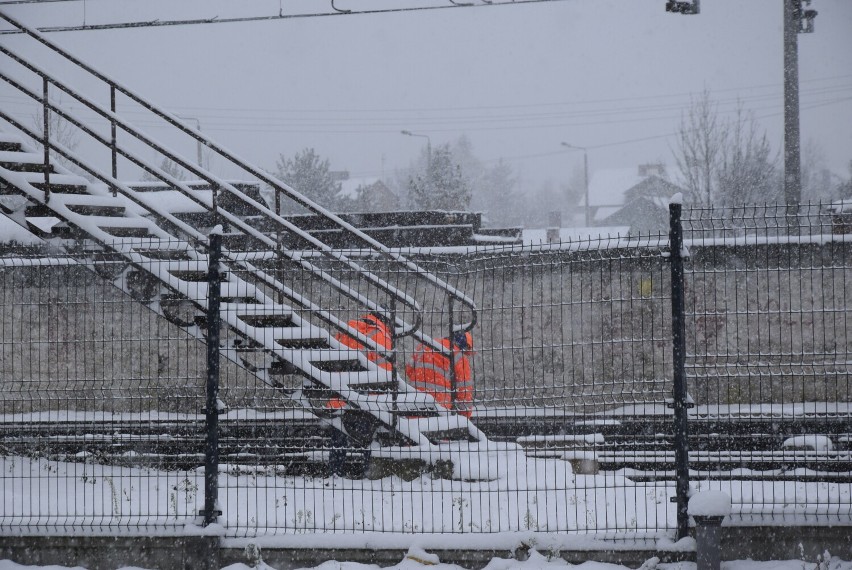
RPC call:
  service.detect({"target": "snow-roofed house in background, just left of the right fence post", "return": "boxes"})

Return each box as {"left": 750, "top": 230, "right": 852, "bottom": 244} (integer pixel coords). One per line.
{"left": 581, "top": 163, "right": 685, "bottom": 235}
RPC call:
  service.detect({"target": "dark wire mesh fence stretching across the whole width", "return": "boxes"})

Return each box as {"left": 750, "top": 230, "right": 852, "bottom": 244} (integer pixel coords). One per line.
{"left": 0, "top": 203, "right": 852, "bottom": 538}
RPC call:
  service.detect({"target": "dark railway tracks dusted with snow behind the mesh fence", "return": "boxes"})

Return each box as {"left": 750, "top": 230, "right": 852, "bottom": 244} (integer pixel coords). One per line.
{"left": 0, "top": 413, "right": 852, "bottom": 482}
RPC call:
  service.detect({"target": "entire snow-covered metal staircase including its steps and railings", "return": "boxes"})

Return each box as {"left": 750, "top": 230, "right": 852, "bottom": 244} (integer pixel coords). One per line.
{"left": 0, "top": 8, "right": 487, "bottom": 461}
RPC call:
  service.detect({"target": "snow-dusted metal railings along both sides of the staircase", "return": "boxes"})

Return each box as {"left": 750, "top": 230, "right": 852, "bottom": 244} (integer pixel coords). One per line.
{"left": 0, "top": 11, "right": 477, "bottom": 359}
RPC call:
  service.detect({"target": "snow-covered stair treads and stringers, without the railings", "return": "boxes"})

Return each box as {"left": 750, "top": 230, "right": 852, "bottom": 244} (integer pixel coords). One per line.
{"left": 0, "top": 127, "right": 485, "bottom": 452}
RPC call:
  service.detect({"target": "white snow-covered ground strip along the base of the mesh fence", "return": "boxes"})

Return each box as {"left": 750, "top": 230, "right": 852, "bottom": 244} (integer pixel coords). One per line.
{"left": 0, "top": 451, "right": 852, "bottom": 536}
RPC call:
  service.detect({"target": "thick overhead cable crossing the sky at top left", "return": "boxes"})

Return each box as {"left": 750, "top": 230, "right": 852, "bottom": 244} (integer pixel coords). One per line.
{"left": 0, "top": 0, "right": 567, "bottom": 35}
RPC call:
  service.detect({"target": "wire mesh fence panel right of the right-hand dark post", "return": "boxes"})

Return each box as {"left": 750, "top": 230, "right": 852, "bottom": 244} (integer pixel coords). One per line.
{"left": 685, "top": 204, "right": 852, "bottom": 521}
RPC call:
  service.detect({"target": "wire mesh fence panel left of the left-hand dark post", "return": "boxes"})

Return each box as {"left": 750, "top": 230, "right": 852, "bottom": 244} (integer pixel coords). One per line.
{"left": 0, "top": 242, "right": 210, "bottom": 533}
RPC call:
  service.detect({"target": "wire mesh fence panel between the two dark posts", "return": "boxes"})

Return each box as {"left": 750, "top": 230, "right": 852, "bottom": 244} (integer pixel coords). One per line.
{"left": 215, "top": 233, "right": 675, "bottom": 537}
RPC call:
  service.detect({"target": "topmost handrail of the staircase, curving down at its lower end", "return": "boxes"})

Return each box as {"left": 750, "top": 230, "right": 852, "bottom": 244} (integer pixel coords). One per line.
{"left": 0, "top": 11, "right": 477, "bottom": 349}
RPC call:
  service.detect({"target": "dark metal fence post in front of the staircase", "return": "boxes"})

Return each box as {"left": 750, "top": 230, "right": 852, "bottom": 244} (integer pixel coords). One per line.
{"left": 200, "top": 226, "right": 222, "bottom": 526}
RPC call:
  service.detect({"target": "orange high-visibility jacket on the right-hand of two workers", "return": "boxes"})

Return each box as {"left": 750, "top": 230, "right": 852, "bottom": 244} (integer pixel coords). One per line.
{"left": 405, "top": 332, "right": 473, "bottom": 418}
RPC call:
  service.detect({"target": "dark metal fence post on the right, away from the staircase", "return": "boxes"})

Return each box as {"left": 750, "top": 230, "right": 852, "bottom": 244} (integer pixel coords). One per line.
{"left": 669, "top": 199, "right": 691, "bottom": 539}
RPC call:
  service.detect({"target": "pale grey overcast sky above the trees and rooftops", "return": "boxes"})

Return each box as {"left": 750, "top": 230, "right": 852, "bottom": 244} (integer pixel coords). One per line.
{"left": 0, "top": 0, "right": 852, "bottom": 193}
